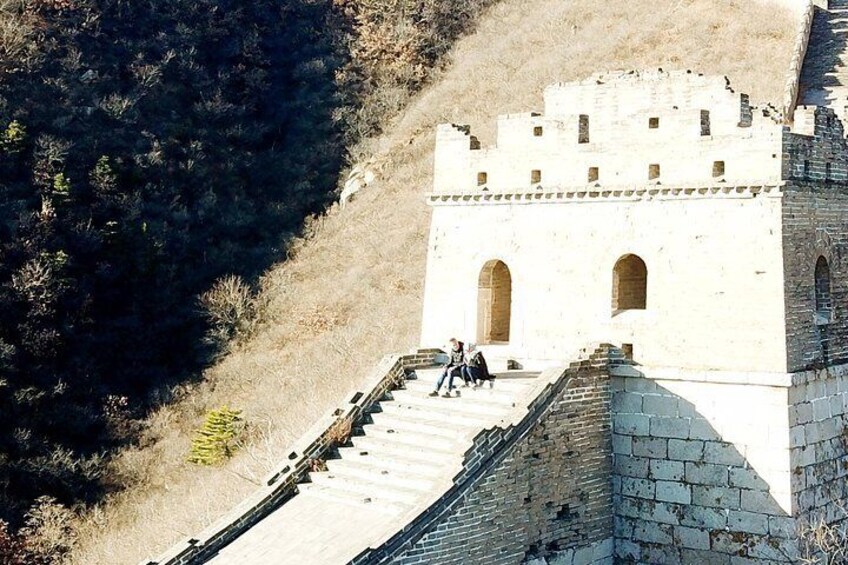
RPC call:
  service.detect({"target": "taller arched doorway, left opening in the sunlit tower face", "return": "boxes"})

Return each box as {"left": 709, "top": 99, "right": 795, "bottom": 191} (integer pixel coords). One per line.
{"left": 477, "top": 260, "right": 512, "bottom": 343}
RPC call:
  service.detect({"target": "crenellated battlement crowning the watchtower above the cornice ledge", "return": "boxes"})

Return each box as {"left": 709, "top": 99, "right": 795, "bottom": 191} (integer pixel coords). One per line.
{"left": 434, "top": 70, "right": 848, "bottom": 193}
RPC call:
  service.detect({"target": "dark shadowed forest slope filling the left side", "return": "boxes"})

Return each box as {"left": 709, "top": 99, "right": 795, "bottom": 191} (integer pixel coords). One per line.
{"left": 0, "top": 0, "right": 491, "bottom": 563}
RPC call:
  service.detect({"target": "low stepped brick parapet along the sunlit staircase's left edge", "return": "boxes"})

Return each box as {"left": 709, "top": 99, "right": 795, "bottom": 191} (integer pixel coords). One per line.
{"left": 140, "top": 349, "right": 444, "bottom": 565}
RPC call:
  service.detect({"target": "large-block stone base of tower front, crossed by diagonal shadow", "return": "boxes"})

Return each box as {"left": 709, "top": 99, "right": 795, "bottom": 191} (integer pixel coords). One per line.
{"left": 612, "top": 371, "right": 797, "bottom": 565}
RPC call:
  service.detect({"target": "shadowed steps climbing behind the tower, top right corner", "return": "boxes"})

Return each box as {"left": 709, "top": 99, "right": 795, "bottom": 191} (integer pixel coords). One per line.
{"left": 798, "top": 0, "right": 848, "bottom": 122}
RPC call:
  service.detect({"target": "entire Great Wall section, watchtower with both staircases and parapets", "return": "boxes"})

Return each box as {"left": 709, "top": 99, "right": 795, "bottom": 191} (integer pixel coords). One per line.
{"left": 144, "top": 0, "right": 848, "bottom": 565}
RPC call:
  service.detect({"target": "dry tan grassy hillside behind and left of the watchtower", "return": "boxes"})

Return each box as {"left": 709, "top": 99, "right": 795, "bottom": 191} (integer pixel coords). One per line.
{"left": 69, "top": 0, "right": 796, "bottom": 565}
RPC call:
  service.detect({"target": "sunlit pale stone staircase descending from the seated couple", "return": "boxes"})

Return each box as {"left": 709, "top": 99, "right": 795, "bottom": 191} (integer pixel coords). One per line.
{"left": 205, "top": 368, "right": 538, "bottom": 565}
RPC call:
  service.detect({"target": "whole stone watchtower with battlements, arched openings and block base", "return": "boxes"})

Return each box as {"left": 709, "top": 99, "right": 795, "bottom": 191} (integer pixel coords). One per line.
{"left": 422, "top": 71, "right": 848, "bottom": 563}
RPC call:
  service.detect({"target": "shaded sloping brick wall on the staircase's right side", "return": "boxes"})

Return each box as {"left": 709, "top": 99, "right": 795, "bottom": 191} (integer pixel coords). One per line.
{"left": 353, "top": 346, "right": 620, "bottom": 565}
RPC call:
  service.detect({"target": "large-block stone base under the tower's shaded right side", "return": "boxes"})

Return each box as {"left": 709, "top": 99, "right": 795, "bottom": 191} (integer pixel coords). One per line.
{"left": 789, "top": 366, "right": 848, "bottom": 523}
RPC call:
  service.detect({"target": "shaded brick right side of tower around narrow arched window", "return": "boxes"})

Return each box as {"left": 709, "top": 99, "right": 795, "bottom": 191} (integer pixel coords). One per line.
{"left": 783, "top": 178, "right": 848, "bottom": 371}
